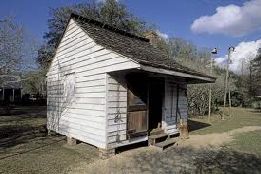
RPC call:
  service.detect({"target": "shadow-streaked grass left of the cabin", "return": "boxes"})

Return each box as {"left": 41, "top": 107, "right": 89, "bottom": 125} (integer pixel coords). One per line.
{"left": 0, "top": 106, "right": 98, "bottom": 174}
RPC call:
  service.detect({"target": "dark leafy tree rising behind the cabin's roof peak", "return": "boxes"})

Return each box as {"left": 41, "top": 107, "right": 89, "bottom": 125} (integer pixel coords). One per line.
{"left": 37, "top": 0, "right": 146, "bottom": 67}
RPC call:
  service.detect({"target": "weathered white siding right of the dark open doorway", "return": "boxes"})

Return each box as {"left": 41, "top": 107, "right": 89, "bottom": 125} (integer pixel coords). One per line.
{"left": 162, "top": 78, "right": 187, "bottom": 134}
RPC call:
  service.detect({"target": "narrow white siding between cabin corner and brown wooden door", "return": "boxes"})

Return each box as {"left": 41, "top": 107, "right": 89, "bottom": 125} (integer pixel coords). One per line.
{"left": 104, "top": 74, "right": 148, "bottom": 149}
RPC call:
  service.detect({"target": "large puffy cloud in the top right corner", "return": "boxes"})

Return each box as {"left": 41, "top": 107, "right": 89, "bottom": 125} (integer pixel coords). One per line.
{"left": 191, "top": 0, "right": 261, "bottom": 36}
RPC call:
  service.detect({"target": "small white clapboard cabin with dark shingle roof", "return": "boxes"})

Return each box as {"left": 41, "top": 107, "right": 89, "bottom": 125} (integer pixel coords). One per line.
{"left": 47, "top": 14, "right": 215, "bottom": 154}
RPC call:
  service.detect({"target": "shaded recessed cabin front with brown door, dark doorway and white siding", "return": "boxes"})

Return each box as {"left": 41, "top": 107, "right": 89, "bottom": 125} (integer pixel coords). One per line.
{"left": 108, "top": 70, "right": 187, "bottom": 147}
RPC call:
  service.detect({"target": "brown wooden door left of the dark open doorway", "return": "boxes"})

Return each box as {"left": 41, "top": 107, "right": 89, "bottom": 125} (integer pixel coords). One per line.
{"left": 127, "top": 73, "right": 148, "bottom": 138}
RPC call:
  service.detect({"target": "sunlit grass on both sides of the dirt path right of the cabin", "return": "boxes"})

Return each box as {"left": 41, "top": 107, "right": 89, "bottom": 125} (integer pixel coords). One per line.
{"left": 190, "top": 108, "right": 261, "bottom": 156}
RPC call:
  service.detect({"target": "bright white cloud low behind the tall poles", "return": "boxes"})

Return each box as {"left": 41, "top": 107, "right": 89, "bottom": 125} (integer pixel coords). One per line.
{"left": 215, "top": 39, "right": 261, "bottom": 73}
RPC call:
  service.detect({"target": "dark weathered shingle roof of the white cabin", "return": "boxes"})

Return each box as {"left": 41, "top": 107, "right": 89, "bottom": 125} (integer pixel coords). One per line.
{"left": 71, "top": 14, "right": 213, "bottom": 78}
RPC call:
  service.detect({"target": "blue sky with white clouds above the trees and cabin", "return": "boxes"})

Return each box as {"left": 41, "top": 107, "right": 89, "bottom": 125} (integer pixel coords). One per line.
{"left": 0, "top": 0, "right": 261, "bottom": 71}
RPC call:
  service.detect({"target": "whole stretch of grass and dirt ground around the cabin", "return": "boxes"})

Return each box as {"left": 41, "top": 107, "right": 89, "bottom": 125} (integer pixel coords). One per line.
{"left": 0, "top": 107, "right": 261, "bottom": 174}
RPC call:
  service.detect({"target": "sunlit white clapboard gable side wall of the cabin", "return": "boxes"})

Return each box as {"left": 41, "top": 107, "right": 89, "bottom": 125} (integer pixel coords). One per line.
{"left": 47, "top": 20, "right": 138, "bottom": 148}
